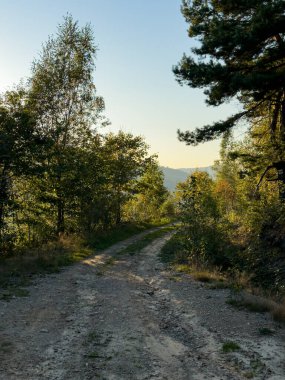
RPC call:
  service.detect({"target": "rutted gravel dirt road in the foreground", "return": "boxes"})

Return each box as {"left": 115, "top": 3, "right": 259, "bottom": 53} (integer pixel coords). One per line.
{"left": 0, "top": 235, "right": 285, "bottom": 380}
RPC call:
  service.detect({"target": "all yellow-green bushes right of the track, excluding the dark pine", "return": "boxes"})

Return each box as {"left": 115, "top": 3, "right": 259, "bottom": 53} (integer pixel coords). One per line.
{"left": 168, "top": 126, "right": 285, "bottom": 297}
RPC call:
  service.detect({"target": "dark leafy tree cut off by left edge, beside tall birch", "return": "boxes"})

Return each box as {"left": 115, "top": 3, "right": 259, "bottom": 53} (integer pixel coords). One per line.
{"left": 0, "top": 88, "right": 44, "bottom": 248}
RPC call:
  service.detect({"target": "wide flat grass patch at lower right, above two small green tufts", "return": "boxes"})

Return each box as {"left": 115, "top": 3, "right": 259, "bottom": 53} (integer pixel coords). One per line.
{"left": 226, "top": 294, "right": 272, "bottom": 313}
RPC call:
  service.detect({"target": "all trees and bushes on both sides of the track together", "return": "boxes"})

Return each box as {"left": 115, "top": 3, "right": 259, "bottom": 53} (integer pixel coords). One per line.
{"left": 0, "top": 0, "right": 285, "bottom": 297}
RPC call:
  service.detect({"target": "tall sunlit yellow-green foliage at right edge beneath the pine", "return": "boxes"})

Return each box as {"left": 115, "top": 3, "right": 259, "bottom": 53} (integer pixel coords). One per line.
{"left": 216, "top": 127, "right": 285, "bottom": 291}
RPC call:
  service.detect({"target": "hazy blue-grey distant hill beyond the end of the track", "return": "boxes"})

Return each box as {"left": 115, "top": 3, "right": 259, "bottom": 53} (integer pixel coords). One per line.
{"left": 160, "top": 166, "right": 214, "bottom": 191}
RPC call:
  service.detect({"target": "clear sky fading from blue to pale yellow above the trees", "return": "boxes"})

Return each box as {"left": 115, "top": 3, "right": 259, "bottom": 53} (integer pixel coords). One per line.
{"left": 0, "top": 0, "right": 240, "bottom": 168}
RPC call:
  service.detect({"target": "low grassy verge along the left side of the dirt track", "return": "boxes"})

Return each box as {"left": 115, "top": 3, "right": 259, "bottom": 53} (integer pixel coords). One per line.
{"left": 0, "top": 223, "right": 173, "bottom": 300}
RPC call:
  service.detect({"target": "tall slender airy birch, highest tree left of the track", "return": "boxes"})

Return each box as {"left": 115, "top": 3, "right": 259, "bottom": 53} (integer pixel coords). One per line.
{"left": 29, "top": 15, "right": 104, "bottom": 233}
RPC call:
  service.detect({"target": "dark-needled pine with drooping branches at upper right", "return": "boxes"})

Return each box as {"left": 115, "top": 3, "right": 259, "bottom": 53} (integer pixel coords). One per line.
{"left": 173, "top": 0, "right": 285, "bottom": 147}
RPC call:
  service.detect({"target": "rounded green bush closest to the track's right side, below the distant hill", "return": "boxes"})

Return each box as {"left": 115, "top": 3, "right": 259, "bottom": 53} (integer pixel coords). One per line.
{"left": 174, "top": 172, "right": 234, "bottom": 268}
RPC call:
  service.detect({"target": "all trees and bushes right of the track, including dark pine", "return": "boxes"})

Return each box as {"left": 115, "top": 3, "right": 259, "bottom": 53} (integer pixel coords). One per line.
{"left": 164, "top": 0, "right": 285, "bottom": 298}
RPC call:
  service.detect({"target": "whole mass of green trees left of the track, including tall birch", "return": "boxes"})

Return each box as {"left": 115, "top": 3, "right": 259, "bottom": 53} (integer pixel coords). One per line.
{"left": 0, "top": 15, "right": 173, "bottom": 258}
